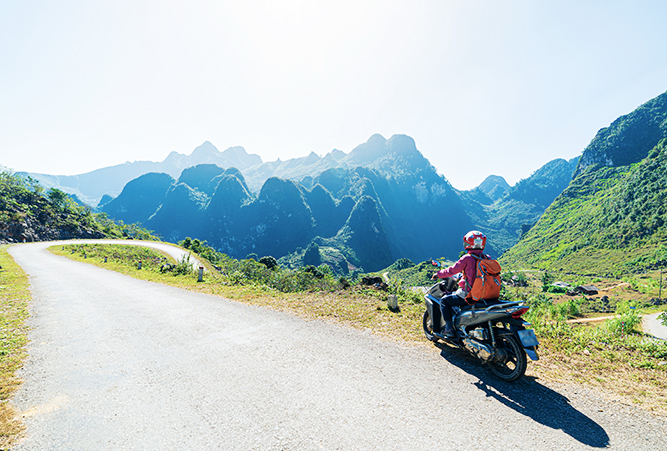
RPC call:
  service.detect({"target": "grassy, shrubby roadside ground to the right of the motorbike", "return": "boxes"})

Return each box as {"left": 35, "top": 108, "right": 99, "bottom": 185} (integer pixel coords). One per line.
{"left": 504, "top": 275, "right": 667, "bottom": 412}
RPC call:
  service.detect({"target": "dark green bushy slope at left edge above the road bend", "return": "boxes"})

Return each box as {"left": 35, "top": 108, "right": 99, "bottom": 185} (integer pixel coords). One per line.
{"left": 0, "top": 171, "right": 157, "bottom": 242}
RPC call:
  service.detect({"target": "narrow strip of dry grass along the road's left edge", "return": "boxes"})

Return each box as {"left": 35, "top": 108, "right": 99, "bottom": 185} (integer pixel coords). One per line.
{"left": 0, "top": 246, "right": 31, "bottom": 449}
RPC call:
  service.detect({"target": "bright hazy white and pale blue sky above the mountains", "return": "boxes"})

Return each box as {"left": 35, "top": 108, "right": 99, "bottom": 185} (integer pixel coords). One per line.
{"left": 0, "top": 0, "right": 667, "bottom": 189}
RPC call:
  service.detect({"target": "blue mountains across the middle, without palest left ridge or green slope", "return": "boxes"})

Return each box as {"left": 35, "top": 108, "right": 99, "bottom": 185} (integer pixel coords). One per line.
{"left": 90, "top": 135, "right": 576, "bottom": 274}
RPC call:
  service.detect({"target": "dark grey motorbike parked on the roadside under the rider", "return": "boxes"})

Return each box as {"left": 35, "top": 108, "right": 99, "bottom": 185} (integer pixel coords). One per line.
{"left": 423, "top": 278, "right": 539, "bottom": 382}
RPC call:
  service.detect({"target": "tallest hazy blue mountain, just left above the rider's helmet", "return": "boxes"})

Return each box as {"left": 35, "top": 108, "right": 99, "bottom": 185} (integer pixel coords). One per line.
{"left": 314, "top": 135, "right": 478, "bottom": 261}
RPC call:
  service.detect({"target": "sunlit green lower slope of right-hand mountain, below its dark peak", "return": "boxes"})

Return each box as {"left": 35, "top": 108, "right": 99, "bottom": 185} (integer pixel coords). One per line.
{"left": 502, "top": 139, "right": 667, "bottom": 275}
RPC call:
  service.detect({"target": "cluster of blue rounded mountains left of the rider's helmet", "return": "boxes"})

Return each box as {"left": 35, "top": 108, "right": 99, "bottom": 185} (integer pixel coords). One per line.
{"left": 102, "top": 135, "right": 480, "bottom": 271}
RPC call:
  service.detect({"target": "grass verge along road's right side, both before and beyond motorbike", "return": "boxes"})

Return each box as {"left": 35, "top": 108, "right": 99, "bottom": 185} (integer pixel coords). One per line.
{"left": 49, "top": 245, "right": 667, "bottom": 413}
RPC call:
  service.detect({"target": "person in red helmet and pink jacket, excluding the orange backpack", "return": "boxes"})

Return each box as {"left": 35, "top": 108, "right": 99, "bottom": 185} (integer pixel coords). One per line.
{"left": 431, "top": 230, "right": 486, "bottom": 338}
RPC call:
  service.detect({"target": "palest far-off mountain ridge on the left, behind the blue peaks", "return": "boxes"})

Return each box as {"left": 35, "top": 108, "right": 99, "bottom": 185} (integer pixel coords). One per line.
{"left": 19, "top": 141, "right": 262, "bottom": 205}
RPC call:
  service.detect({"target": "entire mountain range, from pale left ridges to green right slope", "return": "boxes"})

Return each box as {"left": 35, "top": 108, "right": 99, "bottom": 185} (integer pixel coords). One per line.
{"left": 6, "top": 88, "right": 667, "bottom": 274}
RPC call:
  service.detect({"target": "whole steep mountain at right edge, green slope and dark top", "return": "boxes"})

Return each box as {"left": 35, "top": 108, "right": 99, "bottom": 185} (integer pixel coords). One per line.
{"left": 502, "top": 93, "right": 667, "bottom": 275}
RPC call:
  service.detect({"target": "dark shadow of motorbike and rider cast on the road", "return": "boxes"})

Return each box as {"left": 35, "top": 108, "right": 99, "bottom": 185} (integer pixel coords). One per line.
{"left": 437, "top": 343, "right": 609, "bottom": 448}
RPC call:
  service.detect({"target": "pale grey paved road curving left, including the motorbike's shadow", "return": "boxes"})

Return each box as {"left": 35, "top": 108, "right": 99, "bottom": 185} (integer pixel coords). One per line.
{"left": 10, "top": 243, "right": 667, "bottom": 450}
